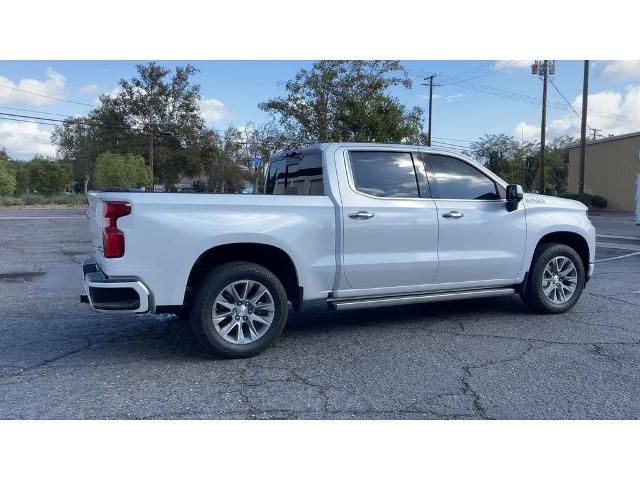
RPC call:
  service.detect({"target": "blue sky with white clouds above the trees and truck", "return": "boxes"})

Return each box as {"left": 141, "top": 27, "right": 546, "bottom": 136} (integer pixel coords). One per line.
{"left": 0, "top": 60, "right": 640, "bottom": 160}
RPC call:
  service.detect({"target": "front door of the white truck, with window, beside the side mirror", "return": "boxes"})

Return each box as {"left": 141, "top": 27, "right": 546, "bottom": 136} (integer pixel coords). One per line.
{"left": 422, "top": 153, "right": 526, "bottom": 288}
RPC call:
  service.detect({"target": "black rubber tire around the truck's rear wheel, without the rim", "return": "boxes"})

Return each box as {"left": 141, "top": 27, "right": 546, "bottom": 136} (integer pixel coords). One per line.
{"left": 189, "top": 262, "right": 288, "bottom": 358}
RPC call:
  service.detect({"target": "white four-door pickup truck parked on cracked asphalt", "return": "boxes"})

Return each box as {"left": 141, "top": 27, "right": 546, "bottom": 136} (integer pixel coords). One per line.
{"left": 82, "top": 143, "right": 595, "bottom": 357}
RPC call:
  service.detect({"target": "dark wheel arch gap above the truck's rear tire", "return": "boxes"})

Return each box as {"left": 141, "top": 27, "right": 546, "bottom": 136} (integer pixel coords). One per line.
{"left": 185, "top": 242, "right": 303, "bottom": 311}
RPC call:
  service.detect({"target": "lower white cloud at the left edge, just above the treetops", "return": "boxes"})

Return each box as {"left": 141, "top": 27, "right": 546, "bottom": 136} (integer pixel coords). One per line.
{"left": 0, "top": 122, "right": 56, "bottom": 158}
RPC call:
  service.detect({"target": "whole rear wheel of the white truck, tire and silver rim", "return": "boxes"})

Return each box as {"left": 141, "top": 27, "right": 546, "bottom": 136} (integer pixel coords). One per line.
{"left": 190, "top": 262, "right": 288, "bottom": 357}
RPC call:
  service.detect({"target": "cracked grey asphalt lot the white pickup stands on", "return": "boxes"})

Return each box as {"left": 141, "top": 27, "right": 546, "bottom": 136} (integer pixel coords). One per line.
{"left": 0, "top": 209, "right": 640, "bottom": 419}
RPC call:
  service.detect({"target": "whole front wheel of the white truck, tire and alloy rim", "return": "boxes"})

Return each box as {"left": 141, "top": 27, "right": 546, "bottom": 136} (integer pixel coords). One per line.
{"left": 522, "top": 243, "right": 585, "bottom": 313}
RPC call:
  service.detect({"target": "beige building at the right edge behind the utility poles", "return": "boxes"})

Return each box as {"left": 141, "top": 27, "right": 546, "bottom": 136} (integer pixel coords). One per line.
{"left": 567, "top": 132, "right": 640, "bottom": 212}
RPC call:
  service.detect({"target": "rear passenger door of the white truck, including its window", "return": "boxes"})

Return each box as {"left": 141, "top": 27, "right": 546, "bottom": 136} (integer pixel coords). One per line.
{"left": 340, "top": 149, "right": 438, "bottom": 288}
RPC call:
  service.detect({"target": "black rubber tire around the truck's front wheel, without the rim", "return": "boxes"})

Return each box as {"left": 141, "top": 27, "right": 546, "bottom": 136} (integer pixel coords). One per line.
{"left": 520, "top": 243, "right": 585, "bottom": 313}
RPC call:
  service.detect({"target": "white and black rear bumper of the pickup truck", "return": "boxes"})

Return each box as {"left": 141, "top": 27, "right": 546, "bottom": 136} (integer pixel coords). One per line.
{"left": 81, "top": 258, "right": 151, "bottom": 313}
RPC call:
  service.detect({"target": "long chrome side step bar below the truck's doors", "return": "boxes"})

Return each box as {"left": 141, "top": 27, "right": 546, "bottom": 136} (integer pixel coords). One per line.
{"left": 327, "top": 287, "right": 515, "bottom": 310}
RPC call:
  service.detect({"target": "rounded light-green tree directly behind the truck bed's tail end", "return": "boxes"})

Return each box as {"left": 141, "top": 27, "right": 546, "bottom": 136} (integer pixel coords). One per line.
{"left": 93, "top": 152, "right": 151, "bottom": 190}
